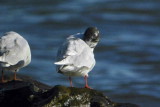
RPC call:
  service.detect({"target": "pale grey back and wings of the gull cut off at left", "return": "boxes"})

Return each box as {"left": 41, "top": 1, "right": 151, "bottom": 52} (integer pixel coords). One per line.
{"left": 0, "top": 32, "right": 31, "bottom": 66}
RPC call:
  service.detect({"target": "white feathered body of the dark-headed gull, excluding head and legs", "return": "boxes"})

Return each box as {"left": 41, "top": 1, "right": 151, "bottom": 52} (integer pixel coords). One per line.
{"left": 55, "top": 34, "right": 95, "bottom": 76}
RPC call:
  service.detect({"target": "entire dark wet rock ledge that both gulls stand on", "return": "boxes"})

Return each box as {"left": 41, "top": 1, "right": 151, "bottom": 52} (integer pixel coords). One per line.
{"left": 0, "top": 75, "right": 139, "bottom": 107}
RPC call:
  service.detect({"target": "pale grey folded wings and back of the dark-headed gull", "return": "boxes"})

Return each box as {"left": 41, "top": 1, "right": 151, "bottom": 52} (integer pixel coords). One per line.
{"left": 55, "top": 36, "right": 95, "bottom": 68}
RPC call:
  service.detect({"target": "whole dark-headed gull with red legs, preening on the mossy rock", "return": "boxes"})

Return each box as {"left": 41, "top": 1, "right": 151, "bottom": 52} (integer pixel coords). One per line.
{"left": 54, "top": 27, "right": 99, "bottom": 88}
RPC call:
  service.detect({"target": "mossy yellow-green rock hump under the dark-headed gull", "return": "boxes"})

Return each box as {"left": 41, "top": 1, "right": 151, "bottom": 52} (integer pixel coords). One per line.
{"left": 34, "top": 85, "right": 112, "bottom": 107}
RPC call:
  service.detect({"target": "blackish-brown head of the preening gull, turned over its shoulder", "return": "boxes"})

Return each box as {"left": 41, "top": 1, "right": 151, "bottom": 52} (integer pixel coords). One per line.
{"left": 83, "top": 27, "right": 99, "bottom": 48}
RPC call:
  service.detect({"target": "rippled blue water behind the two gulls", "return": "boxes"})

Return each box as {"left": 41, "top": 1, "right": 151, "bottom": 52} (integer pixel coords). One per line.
{"left": 0, "top": 0, "right": 160, "bottom": 107}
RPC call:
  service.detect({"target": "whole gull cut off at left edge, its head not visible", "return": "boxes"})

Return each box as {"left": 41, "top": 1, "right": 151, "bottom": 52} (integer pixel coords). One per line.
{"left": 0, "top": 31, "right": 31, "bottom": 83}
